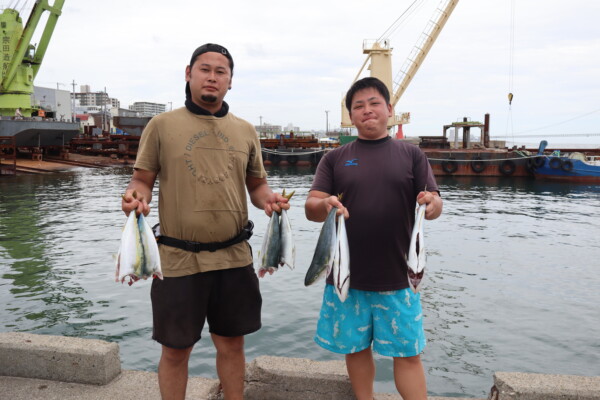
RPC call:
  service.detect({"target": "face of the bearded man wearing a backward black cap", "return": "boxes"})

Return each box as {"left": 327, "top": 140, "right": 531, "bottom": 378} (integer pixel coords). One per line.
{"left": 185, "top": 51, "right": 231, "bottom": 113}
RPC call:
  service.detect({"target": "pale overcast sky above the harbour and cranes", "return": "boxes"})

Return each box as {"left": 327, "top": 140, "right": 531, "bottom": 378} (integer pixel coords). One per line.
{"left": 16, "top": 0, "right": 600, "bottom": 146}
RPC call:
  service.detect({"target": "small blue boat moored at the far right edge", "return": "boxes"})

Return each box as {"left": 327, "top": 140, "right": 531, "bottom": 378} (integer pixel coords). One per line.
{"left": 533, "top": 140, "right": 600, "bottom": 183}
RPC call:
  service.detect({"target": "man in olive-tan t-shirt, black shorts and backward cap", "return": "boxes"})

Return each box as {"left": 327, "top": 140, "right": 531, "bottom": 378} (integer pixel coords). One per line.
{"left": 121, "top": 43, "right": 289, "bottom": 400}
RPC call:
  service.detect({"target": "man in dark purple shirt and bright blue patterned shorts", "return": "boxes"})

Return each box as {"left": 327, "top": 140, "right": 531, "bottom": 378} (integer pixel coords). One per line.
{"left": 305, "top": 78, "right": 443, "bottom": 400}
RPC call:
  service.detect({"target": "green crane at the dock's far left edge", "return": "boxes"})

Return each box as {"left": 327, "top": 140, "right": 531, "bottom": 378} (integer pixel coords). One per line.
{"left": 0, "top": 0, "right": 65, "bottom": 116}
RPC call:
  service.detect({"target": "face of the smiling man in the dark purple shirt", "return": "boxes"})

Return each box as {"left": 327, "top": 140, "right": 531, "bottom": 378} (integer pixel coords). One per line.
{"left": 350, "top": 88, "right": 392, "bottom": 140}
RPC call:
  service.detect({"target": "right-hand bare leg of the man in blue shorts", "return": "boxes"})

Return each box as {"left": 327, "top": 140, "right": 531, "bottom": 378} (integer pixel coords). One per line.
{"left": 394, "top": 356, "right": 427, "bottom": 400}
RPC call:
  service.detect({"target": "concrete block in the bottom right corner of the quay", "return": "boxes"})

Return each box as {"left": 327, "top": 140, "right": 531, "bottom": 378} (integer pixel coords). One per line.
{"left": 488, "top": 372, "right": 600, "bottom": 400}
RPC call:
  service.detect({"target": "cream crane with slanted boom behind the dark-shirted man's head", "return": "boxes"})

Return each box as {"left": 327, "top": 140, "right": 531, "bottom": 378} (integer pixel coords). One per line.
{"left": 341, "top": 0, "right": 458, "bottom": 138}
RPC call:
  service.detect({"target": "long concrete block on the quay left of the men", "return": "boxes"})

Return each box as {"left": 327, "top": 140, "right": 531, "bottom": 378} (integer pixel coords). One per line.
{"left": 0, "top": 332, "right": 121, "bottom": 385}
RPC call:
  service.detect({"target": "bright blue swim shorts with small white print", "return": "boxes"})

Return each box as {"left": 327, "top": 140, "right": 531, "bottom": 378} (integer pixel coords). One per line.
{"left": 315, "top": 285, "right": 426, "bottom": 357}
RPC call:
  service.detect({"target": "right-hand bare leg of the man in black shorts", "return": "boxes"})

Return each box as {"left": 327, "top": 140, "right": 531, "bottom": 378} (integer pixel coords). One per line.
{"left": 211, "top": 333, "right": 246, "bottom": 400}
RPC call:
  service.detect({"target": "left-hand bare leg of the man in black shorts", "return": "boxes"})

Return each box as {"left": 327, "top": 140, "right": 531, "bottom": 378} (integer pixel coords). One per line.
{"left": 158, "top": 346, "right": 193, "bottom": 400}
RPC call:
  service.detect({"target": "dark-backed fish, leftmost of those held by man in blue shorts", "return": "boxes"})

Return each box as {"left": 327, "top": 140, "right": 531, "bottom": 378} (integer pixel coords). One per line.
{"left": 304, "top": 207, "right": 337, "bottom": 286}
